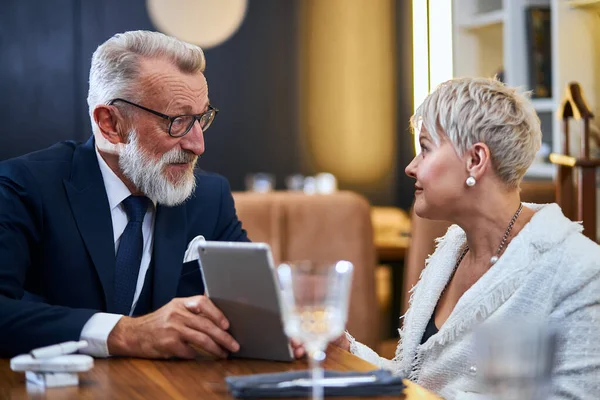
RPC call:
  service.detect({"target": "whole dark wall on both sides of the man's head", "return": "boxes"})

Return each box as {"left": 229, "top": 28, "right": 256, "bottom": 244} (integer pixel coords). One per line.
{"left": 0, "top": 0, "right": 299, "bottom": 194}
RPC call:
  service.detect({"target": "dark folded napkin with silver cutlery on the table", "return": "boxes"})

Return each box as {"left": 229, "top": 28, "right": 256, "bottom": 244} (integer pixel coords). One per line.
{"left": 225, "top": 369, "right": 404, "bottom": 398}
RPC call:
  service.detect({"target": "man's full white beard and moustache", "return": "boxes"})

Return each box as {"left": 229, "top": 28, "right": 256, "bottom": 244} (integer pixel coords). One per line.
{"left": 119, "top": 130, "right": 198, "bottom": 206}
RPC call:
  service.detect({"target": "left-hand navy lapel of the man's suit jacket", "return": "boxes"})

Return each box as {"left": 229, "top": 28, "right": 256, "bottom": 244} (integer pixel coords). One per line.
{"left": 63, "top": 137, "right": 115, "bottom": 312}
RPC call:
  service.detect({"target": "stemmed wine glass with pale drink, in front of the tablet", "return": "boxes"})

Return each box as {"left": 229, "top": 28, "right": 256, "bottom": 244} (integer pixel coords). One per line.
{"left": 277, "top": 261, "right": 354, "bottom": 399}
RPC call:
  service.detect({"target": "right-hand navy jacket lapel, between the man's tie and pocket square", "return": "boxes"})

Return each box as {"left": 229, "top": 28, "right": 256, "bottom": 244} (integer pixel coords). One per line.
{"left": 152, "top": 205, "right": 187, "bottom": 309}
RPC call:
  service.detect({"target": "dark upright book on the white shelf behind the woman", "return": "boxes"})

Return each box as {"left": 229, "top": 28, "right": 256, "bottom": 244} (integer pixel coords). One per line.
{"left": 525, "top": 7, "right": 552, "bottom": 98}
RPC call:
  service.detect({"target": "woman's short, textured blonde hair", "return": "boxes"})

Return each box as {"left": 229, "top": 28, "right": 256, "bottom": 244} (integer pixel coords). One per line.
{"left": 411, "top": 78, "right": 542, "bottom": 188}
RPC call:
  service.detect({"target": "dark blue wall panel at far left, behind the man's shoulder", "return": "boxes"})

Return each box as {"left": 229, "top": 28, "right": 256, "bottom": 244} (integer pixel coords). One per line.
{"left": 0, "top": 0, "right": 81, "bottom": 159}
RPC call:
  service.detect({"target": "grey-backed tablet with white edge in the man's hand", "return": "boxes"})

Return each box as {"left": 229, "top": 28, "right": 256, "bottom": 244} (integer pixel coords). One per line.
{"left": 198, "top": 242, "right": 294, "bottom": 361}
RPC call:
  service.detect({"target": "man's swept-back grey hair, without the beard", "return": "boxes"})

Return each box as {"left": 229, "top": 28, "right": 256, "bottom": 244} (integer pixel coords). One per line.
{"left": 88, "top": 31, "right": 206, "bottom": 128}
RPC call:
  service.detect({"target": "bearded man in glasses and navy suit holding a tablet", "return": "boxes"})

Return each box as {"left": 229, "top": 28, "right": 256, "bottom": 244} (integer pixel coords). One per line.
{"left": 0, "top": 31, "right": 248, "bottom": 358}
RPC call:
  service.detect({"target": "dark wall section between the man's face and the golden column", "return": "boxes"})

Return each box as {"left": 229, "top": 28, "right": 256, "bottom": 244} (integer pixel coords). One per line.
{"left": 200, "top": 0, "right": 301, "bottom": 188}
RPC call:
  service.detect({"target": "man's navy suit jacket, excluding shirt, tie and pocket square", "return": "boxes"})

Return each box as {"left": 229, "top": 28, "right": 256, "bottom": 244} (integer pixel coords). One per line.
{"left": 0, "top": 138, "right": 248, "bottom": 357}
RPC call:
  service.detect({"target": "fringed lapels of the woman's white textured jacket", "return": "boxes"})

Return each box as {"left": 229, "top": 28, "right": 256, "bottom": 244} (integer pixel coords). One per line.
{"left": 400, "top": 203, "right": 582, "bottom": 379}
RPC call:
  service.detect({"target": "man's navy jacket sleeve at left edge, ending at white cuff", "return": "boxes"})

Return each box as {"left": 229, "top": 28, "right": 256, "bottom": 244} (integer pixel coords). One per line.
{"left": 0, "top": 163, "right": 97, "bottom": 357}
